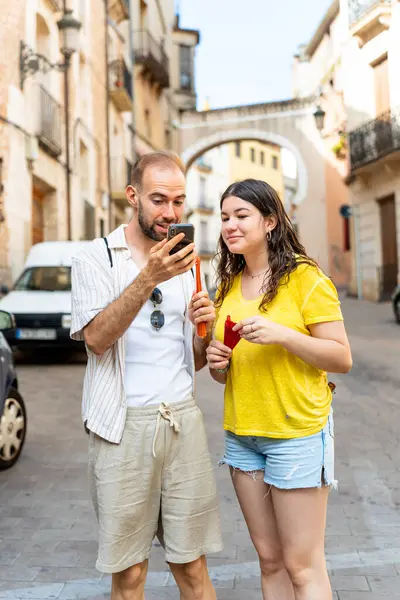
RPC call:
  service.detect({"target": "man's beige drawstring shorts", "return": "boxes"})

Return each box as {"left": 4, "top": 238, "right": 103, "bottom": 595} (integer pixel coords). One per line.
{"left": 89, "top": 400, "right": 222, "bottom": 573}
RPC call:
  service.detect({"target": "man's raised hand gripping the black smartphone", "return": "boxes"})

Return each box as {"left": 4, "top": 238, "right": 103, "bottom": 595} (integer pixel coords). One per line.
{"left": 143, "top": 233, "right": 196, "bottom": 287}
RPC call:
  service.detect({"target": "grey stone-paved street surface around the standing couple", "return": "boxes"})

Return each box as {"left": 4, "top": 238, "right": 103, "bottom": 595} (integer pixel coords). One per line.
{"left": 0, "top": 299, "right": 400, "bottom": 600}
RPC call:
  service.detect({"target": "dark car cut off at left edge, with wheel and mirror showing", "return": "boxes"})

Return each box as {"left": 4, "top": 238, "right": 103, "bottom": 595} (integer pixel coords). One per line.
{"left": 0, "top": 311, "right": 27, "bottom": 471}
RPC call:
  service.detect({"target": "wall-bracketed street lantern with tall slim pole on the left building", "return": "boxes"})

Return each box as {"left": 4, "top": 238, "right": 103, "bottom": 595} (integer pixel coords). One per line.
{"left": 19, "top": 7, "right": 81, "bottom": 240}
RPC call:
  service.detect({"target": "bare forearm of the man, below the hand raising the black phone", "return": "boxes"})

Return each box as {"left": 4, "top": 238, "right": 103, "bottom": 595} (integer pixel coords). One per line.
{"left": 83, "top": 271, "right": 154, "bottom": 355}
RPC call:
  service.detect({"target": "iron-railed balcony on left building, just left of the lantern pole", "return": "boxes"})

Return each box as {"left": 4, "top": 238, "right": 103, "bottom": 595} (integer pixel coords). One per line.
{"left": 35, "top": 84, "right": 62, "bottom": 158}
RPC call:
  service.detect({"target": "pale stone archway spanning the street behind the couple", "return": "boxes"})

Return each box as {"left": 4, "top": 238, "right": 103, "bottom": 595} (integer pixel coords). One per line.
{"left": 178, "top": 98, "right": 329, "bottom": 272}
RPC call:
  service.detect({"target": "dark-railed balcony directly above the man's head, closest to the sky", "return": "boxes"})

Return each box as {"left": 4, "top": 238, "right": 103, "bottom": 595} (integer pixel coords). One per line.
{"left": 133, "top": 30, "right": 169, "bottom": 88}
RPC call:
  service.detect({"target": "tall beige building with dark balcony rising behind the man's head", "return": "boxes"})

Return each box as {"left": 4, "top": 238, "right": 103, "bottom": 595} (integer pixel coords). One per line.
{"left": 109, "top": 0, "right": 200, "bottom": 225}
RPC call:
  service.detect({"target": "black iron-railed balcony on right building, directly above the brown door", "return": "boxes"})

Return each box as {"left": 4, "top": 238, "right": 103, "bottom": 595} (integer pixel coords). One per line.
{"left": 349, "top": 106, "right": 400, "bottom": 172}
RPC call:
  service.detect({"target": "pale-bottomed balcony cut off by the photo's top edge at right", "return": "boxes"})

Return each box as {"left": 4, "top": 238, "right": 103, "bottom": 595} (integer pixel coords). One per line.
{"left": 348, "top": 0, "right": 392, "bottom": 44}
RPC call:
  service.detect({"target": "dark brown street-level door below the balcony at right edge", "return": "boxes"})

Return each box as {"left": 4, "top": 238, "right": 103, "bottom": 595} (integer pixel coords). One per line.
{"left": 378, "top": 194, "right": 398, "bottom": 300}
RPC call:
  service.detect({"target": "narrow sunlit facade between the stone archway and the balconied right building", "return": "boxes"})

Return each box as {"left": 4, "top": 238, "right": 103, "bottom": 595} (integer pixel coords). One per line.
{"left": 292, "top": 0, "right": 354, "bottom": 290}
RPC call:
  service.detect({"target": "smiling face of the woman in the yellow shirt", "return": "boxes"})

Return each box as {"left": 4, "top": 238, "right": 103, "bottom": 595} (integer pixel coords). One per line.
{"left": 221, "top": 196, "right": 272, "bottom": 255}
